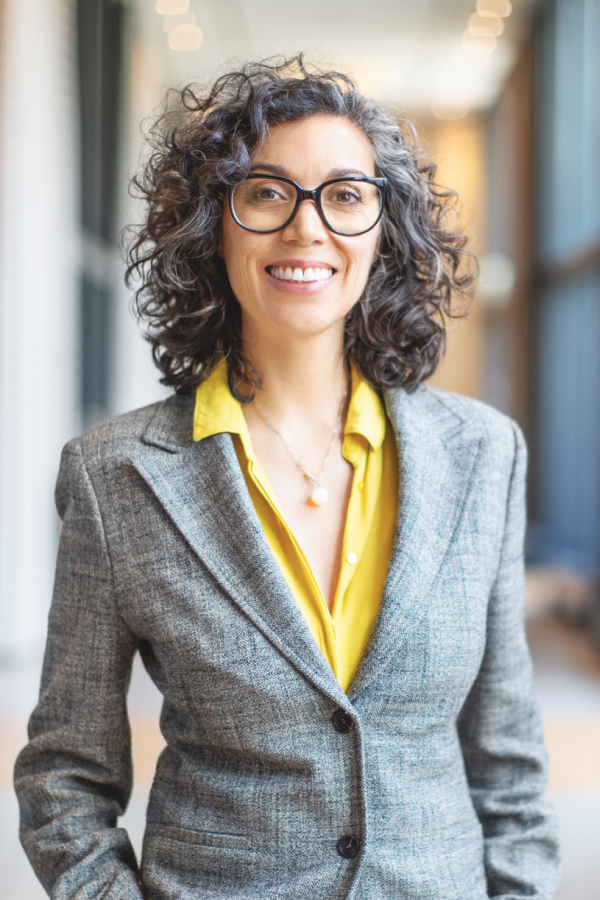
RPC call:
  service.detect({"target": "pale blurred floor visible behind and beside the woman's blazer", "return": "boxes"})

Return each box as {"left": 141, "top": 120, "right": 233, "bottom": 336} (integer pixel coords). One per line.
{"left": 0, "top": 618, "right": 600, "bottom": 900}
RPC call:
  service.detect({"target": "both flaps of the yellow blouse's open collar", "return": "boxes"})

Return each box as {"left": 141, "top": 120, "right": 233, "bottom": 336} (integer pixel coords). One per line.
{"left": 194, "top": 360, "right": 385, "bottom": 459}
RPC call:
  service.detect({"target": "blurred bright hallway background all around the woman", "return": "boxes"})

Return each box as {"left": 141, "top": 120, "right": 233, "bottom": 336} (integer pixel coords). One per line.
{"left": 0, "top": 0, "right": 600, "bottom": 900}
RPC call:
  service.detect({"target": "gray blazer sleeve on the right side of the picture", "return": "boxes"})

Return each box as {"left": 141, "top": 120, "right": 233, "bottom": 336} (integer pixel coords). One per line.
{"left": 459, "top": 425, "right": 558, "bottom": 900}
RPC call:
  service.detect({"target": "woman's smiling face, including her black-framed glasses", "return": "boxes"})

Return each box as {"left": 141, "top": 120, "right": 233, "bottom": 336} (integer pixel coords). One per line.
{"left": 221, "top": 115, "right": 385, "bottom": 356}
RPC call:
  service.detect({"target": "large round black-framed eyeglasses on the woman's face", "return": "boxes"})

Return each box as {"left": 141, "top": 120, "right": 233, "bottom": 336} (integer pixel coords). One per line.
{"left": 229, "top": 172, "right": 386, "bottom": 236}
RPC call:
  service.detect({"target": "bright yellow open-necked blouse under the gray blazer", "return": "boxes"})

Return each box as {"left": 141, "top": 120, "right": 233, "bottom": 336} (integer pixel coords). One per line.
{"left": 194, "top": 362, "right": 399, "bottom": 691}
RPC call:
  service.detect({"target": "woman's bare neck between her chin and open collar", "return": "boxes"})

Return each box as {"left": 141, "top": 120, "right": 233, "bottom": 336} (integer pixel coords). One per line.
{"left": 244, "top": 326, "right": 348, "bottom": 425}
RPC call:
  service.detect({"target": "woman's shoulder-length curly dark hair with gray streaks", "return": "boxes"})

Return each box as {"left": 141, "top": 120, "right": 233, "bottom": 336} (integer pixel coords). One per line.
{"left": 126, "top": 56, "right": 475, "bottom": 401}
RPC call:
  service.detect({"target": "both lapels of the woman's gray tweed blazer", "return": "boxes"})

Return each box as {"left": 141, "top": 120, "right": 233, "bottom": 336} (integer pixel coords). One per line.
{"left": 132, "top": 389, "right": 480, "bottom": 706}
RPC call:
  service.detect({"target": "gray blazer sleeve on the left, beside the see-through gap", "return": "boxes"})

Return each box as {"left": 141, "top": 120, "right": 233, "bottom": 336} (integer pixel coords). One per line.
{"left": 15, "top": 441, "right": 142, "bottom": 900}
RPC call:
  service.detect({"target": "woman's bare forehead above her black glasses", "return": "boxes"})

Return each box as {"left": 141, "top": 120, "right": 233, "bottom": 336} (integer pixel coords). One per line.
{"left": 252, "top": 115, "right": 375, "bottom": 179}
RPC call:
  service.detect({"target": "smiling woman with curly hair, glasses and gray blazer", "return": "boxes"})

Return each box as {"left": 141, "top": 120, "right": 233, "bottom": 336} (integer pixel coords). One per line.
{"left": 16, "top": 60, "right": 557, "bottom": 900}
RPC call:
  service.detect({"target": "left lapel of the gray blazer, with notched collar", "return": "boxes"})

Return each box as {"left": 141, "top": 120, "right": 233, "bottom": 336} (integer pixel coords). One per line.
{"left": 132, "top": 397, "right": 348, "bottom": 705}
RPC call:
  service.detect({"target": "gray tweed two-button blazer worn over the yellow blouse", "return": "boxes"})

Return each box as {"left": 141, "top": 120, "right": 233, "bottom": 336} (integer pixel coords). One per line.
{"left": 16, "top": 388, "right": 557, "bottom": 900}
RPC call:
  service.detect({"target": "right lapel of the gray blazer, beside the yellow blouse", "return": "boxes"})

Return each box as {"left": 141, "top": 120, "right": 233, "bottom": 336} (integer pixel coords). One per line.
{"left": 349, "top": 389, "right": 481, "bottom": 700}
